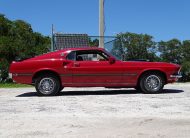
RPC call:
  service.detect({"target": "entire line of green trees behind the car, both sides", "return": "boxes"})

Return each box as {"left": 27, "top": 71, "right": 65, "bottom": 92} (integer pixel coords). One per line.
{"left": 0, "top": 14, "right": 190, "bottom": 82}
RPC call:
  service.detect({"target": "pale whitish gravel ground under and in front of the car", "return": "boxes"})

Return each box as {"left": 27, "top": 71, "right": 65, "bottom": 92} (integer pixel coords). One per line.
{"left": 0, "top": 83, "right": 190, "bottom": 138}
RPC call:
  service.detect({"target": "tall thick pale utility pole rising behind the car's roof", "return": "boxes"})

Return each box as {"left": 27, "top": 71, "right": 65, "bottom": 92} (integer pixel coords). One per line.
{"left": 99, "top": 0, "right": 104, "bottom": 48}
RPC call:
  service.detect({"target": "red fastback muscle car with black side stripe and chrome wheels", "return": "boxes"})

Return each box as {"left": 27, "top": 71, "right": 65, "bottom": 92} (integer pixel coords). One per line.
{"left": 10, "top": 48, "right": 181, "bottom": 96}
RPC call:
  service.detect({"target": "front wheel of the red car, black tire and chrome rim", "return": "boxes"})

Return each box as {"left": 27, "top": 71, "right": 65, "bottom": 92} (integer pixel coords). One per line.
{"left": 140, "top": 73, "right": 165, "bottom": 94}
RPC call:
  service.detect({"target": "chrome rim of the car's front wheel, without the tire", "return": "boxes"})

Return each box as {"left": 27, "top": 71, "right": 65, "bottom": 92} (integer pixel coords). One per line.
{"left": 145, "top": 75, "right": 162, "bottom": 91}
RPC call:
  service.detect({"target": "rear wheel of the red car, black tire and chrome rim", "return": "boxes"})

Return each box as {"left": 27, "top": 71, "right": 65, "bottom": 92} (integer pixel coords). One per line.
{"left": 35, "top": 74, "right": 61, "bottom": 96}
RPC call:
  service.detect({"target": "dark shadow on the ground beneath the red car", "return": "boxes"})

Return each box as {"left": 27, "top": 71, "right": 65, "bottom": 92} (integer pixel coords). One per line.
{"left": 16, "top": 89, "right": 184, "bottom": 97}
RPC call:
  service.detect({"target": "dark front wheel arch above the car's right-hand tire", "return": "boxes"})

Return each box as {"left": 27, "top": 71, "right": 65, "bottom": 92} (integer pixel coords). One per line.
{"left": 137, "top": 69, "right": 167, "bottom": 86}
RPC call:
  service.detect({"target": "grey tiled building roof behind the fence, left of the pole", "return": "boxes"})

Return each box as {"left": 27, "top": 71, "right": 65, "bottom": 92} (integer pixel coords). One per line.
{"left": 53, "top": 33, "right": 89, "bottom": 50}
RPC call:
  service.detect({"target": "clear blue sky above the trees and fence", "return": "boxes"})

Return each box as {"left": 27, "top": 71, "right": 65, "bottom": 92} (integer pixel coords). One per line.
{"left": 0, "top": 0, "right": 190, "bottom": 41}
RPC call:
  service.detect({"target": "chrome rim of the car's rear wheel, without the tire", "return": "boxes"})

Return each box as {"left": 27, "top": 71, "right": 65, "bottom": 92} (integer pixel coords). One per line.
{"left": 38, "top": 78, "right": 55, "bottom": 95}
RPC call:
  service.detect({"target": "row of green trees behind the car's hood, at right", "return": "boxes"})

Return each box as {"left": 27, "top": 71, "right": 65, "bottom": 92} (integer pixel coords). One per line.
{"left": 112, "top": 32, "right": 190, "bottom": 82}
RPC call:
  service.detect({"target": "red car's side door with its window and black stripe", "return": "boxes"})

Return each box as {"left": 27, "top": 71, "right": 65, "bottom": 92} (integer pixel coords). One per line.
{"left": 72, "top": 50, "right": 123, "bottom": 86}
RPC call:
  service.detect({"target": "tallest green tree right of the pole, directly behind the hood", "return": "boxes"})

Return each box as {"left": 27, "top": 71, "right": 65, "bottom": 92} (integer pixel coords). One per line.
{"left": 117, "top": 32, "right": 157, "bottom": 60}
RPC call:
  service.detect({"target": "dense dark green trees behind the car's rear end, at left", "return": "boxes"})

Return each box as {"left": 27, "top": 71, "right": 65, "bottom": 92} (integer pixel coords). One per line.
{"left": 0, "top": 14, "right": 50, "bottom": 80}
